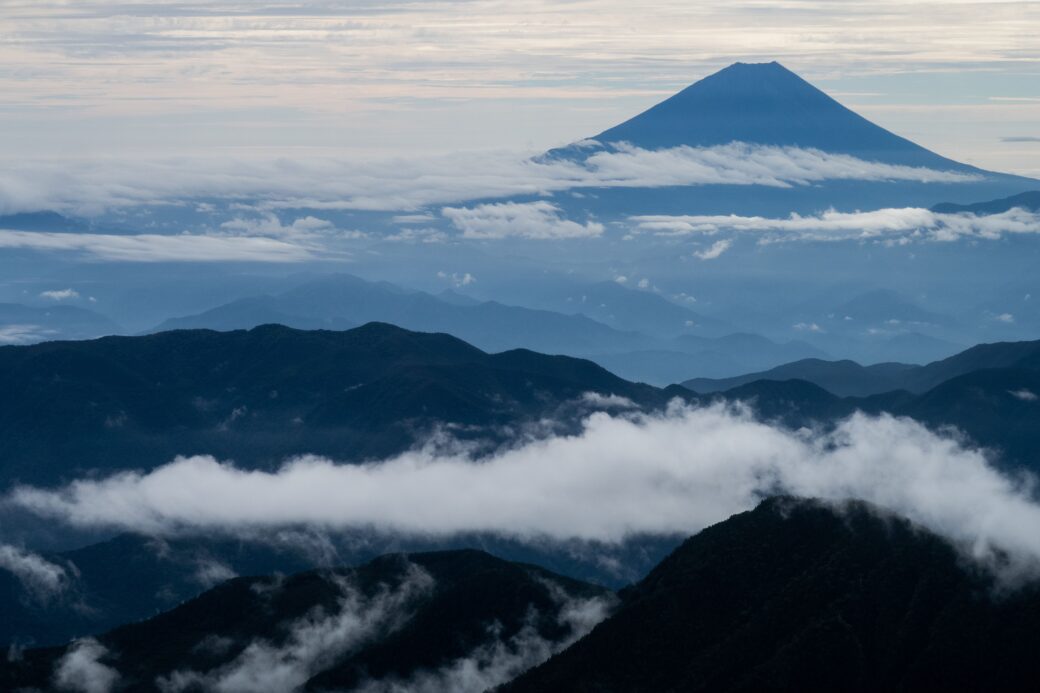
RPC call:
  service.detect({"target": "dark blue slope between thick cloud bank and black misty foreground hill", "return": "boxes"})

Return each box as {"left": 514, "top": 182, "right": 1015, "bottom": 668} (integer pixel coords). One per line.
{"left": 0, "top": 530, "right": 681, "bottom": 649}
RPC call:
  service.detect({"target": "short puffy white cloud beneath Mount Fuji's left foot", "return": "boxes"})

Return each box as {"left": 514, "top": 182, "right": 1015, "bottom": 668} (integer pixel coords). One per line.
{"left": 441, "top": 201, "right": 603, "bottom": 239}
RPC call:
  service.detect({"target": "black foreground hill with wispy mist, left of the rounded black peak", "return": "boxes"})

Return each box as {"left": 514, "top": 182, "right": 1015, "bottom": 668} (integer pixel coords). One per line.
{"left": 0, "top": 550, "right": 612, "bottom": 691}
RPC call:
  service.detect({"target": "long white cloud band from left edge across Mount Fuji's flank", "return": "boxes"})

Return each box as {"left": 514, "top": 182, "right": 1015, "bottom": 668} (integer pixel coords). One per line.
{"left": 0, "top": 143, "right": 979, "bottom": 218}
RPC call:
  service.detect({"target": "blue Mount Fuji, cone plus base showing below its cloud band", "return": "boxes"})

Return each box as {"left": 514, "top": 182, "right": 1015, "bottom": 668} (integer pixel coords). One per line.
{"left": 541, "top": 62, "right": 1040, "bottom": 217}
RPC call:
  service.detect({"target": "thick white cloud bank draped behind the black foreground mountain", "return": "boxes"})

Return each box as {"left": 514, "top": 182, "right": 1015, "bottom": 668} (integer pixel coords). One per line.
{"left": 12, "top": 404, "right": 1040, "bottom": 574}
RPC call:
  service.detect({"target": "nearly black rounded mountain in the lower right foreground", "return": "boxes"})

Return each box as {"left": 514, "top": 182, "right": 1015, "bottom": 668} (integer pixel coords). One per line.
{"left": 503, "top": 498, "right": 1040, "bottom": 693}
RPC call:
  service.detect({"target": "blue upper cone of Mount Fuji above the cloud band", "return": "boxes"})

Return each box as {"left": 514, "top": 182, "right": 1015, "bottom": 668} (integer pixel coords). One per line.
{"left": 594, "top": 62, "right": 970, "bottom": 170}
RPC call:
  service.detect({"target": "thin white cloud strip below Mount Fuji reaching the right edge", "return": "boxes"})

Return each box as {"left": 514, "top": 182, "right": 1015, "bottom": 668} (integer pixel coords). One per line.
{"left": 630, "top": 207, "right": 1040, "bottom": 242}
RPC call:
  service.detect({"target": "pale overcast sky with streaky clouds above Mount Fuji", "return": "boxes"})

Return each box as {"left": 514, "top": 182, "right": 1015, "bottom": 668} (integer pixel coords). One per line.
{"left": 0, "top": 0, "right": 1040, "bottom": 174}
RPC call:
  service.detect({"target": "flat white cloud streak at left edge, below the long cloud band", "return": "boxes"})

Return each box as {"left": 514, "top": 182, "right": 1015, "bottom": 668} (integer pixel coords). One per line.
{"left": 0, "top": 230, "right": 314, "bottom": 262}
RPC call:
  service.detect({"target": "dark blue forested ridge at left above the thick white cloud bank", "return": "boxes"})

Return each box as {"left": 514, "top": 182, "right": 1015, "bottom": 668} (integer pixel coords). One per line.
{"left": 0, "top": 324, "right": 668, "bottom": 484}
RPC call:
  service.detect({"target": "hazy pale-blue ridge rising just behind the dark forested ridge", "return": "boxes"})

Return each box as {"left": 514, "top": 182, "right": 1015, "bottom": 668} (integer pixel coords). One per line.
{"left": 148, "top": 275, "right": 827, "bottom": 385}
